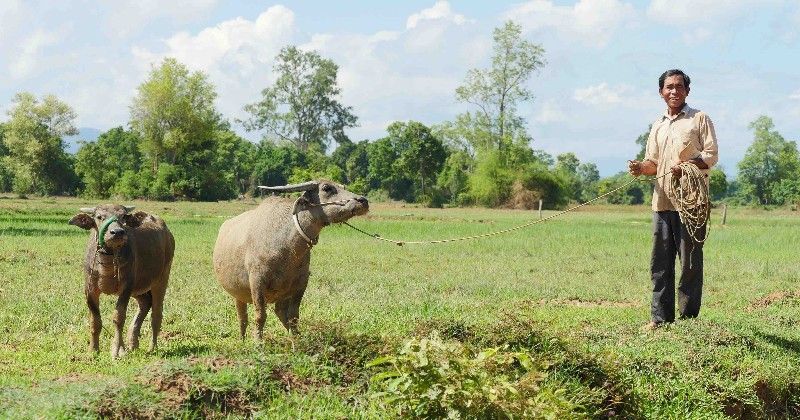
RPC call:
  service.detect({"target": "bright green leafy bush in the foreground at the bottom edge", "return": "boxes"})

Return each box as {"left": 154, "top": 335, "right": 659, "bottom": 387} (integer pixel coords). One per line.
{"left": 369, "top": 333, "right": 570, "bottom": 418}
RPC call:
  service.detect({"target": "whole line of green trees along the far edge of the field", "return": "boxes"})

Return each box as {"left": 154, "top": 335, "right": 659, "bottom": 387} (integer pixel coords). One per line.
{"left": 0, "top": 22, "right": 800, "bottom": 208}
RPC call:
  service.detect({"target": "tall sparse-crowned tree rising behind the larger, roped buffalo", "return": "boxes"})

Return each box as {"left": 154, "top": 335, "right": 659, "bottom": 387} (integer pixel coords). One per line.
{"left": 244, "top": 46, "right": 358, "bottom": 152}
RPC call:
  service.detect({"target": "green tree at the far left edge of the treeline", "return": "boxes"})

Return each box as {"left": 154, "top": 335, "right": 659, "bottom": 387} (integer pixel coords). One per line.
{"left": 3, "top": 92, "right": 78, "bottom": 195}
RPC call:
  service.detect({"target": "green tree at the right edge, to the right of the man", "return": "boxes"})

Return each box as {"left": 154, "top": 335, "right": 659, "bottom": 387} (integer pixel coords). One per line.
{"left": 738, "top": 115, "right": 800, "bottom": 204}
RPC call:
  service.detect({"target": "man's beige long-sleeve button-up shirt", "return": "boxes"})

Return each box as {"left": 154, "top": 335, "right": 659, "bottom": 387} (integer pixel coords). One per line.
{"left": 644, "top": 105, "right": 719, "bottom": 211}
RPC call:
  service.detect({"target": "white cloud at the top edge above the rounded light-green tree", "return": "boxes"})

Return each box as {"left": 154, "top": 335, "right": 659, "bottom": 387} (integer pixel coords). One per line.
{"left": 107, "top": 0, "right": 218, "bottom": 37}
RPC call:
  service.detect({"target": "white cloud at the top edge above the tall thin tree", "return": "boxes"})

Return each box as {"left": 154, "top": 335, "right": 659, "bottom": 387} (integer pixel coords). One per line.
{"left": 505, "top": 0, "right": 636, "bottom": 47}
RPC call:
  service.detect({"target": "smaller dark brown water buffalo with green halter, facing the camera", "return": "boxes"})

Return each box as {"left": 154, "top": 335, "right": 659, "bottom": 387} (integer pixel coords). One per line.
{"left": 69, "top": 204, "right": 175, "bottom": 358}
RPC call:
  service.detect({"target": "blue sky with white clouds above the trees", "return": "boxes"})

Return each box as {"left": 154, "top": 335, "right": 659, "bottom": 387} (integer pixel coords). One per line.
{"left": 0, "top": 0, "right": 800, "bottom": 176}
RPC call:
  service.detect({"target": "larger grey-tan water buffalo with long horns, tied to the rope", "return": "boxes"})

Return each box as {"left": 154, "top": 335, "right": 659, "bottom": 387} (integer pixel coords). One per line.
{"left": 209, "top": 180, "right": 369, "bottom": 340}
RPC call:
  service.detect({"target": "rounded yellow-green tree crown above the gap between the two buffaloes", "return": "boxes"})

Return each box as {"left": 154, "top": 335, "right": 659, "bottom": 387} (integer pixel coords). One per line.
{"left": 130, "top": 58, "right": 221, "bottom": 173}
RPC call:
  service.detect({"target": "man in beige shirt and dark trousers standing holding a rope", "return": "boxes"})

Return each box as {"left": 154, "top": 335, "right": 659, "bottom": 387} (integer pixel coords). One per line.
{"left": 628, "top": 69, "right": 718, "bottom": 329}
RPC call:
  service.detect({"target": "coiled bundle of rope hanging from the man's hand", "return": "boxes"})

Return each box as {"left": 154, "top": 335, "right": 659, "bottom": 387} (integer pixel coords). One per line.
{"left": 666, "top": 162, "right": 711, "bottom": 245}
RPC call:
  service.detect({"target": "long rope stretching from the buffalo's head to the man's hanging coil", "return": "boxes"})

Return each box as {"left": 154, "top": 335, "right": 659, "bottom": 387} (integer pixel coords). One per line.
{"left": 342, "top": 162, "right": 711, "bottom": 246}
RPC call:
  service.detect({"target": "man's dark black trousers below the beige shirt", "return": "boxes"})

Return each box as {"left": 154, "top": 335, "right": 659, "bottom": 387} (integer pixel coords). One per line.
{"left": 650, "top": 211, "right": 706, "bottom": 323}
